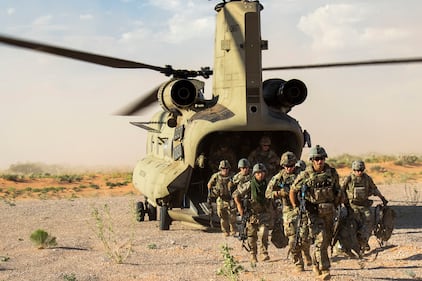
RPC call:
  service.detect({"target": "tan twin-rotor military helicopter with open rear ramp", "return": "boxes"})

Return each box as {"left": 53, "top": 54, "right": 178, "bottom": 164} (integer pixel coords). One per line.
{"left": 0, "top": 0, "right": 422, "bottom": 230}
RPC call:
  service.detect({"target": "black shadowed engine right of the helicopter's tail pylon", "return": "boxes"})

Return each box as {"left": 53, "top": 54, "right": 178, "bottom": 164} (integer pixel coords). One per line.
{"left": 262, "top": 78, "right": 308, "bottom": 113}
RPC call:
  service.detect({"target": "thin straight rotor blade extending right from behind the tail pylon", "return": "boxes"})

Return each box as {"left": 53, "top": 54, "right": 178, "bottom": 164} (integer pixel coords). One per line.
{"left": 262, "top": 57, "right": 422, "bottom": 71}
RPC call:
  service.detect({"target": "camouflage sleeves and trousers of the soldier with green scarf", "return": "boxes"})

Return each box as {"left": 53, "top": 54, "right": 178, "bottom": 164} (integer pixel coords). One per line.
{"left": 233, "top": 177, "right": 273, "bottom": 258}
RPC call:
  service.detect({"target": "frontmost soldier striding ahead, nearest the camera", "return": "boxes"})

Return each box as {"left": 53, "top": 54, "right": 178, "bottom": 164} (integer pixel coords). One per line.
{"left": 289, "top": 145, "right": 341, "bottom": 280}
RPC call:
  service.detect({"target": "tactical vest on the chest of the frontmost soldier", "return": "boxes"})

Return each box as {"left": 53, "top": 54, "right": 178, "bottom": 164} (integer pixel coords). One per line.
{"left": 305, "top": 167, "right": 335, "bottom": 204}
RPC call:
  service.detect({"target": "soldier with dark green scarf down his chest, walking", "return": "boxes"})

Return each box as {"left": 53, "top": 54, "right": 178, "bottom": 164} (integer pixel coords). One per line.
{"left": 233, "top": 163, "right": 271, "bottom": 265}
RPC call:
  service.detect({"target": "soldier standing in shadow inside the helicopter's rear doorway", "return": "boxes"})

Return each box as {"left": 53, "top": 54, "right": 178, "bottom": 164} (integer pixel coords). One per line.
{"left": 248, "top": 136, "right": 279, "bottom": 179}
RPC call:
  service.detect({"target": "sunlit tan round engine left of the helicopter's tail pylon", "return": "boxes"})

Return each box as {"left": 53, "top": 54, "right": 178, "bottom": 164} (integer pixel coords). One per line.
{"left": 157, "top": 79, "right": 204, "bottom": 113}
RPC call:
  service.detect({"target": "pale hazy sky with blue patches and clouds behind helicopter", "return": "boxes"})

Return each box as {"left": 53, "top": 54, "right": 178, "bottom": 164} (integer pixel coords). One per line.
{"left": 0, "top": 0, "right": 422, "bottom": 169}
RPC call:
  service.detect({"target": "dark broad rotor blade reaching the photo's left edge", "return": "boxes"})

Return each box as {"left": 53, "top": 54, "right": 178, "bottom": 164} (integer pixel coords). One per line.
{"left": 0, "top": 34, "right": 167, "bottom": 72}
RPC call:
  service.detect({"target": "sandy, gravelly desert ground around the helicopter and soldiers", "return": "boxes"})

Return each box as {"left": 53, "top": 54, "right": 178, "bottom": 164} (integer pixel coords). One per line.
{"left": 0, "top": 160, "right": 422, "bottom": 281}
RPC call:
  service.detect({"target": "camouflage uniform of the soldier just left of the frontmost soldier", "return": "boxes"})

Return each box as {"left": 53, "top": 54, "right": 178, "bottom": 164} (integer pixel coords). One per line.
{"left": 265, "top": 167, "right": 311, "bottom": 270}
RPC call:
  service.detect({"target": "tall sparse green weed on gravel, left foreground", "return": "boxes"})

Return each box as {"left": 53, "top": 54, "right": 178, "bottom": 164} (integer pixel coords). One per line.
{"left": 91, "top": 202, "right": 136, "bottom": 264}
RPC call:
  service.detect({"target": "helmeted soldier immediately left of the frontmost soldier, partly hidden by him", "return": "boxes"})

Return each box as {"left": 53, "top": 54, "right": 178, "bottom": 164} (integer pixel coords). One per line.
{"left": 265, "top": 151, "right": 312, "bottom": 271}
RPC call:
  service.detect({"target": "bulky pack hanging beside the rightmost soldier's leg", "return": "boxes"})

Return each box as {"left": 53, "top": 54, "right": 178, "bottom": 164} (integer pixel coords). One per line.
{"left": 374, "top": 204, "right": 396, "bottom": 246}
